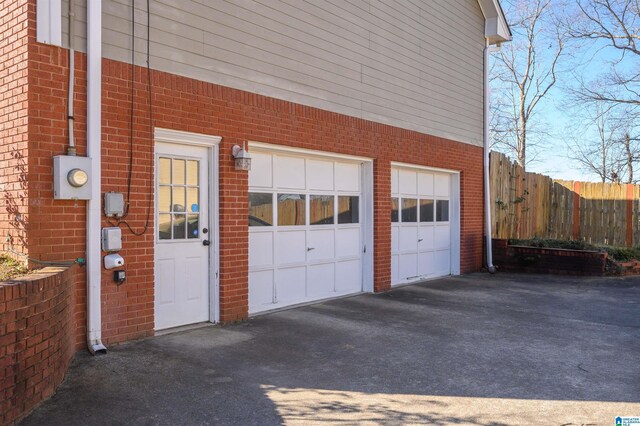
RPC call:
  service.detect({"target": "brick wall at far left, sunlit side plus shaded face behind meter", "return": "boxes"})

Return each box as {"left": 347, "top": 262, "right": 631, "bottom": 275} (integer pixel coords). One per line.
{"left": 0, "top": 0, "right": 86, "bottom": 348}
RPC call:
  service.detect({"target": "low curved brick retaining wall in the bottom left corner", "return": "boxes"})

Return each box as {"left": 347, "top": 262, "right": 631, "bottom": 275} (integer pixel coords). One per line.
{"left": 0, "top": 268, "right": 75, "bottom": 425}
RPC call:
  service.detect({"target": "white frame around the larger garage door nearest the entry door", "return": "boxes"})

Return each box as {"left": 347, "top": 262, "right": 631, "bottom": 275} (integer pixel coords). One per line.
{"left": 248, "top": 140, "right": 374, "bottom": 293}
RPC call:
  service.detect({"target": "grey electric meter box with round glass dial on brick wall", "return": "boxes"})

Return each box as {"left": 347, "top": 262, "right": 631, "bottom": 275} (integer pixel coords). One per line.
{"left": 53, "top": 155, "right": 91, "bottom": 200}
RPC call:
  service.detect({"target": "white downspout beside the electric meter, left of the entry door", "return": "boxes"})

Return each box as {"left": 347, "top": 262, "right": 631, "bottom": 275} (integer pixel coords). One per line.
{"left": 87, "top": 0, "right": 107, "bottom": 355}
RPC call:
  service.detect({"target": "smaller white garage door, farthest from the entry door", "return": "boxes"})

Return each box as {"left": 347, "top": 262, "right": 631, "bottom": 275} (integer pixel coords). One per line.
{"left": 391, "top": 167, "right": 456, "bottom": 285}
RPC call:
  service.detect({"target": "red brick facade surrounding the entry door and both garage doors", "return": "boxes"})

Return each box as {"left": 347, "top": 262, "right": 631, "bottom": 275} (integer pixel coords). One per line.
{"left": 30, "top": 45, "right": 483, "bottom": 344}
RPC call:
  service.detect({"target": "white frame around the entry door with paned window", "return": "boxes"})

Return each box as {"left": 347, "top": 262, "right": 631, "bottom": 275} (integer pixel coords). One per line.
{"left": 153, "top": 127, "right": 222, "bottom": 323}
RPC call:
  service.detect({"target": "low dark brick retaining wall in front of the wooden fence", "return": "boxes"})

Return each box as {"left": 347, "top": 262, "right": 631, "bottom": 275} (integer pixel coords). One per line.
{"left": 493, "top": 240, "right": 608, "bottom": 276}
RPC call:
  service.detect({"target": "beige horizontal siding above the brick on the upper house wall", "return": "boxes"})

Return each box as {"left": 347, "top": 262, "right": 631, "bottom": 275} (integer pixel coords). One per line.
{"left": 63, "top": 0, "right": 484, "bottom": 145}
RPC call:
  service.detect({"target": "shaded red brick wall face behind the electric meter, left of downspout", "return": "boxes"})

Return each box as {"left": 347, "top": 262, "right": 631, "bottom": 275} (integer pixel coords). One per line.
{"left": 28, "top": 43, "right": 86, "bottom": 349}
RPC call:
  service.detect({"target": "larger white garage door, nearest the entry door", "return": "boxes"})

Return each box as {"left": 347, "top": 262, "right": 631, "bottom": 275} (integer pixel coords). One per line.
{"left": 249, "top": 150, "right": 365, "bottom": 313}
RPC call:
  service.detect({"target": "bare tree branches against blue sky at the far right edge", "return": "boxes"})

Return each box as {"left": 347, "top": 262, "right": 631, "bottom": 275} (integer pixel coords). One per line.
{"left": 562, "top": 0, "right": 640, "bottom": 183}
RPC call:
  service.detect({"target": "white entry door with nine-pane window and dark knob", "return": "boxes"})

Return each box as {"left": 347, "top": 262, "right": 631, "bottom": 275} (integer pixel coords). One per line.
{"left": 155, "top": 143, "right": 212, "bottom": 330}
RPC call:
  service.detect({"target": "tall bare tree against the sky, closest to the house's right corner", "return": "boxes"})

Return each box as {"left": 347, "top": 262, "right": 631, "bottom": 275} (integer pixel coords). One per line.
{"left": 491, "top": 0, "right": 565, "bottom": 168}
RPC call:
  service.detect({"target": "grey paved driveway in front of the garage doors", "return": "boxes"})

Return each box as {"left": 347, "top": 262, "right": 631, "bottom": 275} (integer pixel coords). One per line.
{"left": 24, "top": 274, "right": 640, "bottom": 425}
